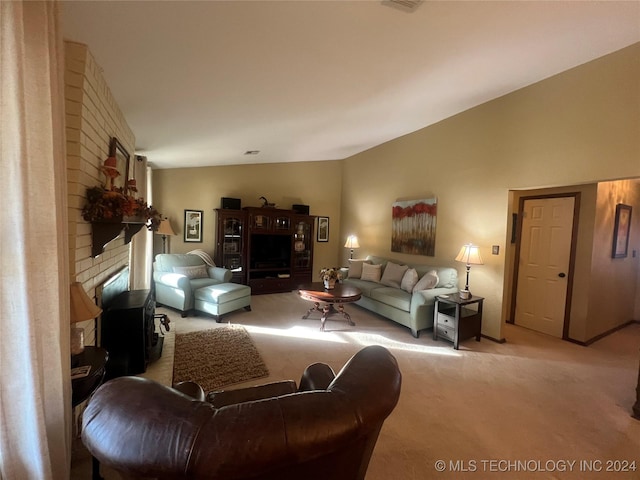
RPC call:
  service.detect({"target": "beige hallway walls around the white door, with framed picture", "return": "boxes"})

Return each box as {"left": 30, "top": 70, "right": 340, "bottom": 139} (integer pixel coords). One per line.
{"left": 504, "top": 180, "right": 640, "bottom": 342}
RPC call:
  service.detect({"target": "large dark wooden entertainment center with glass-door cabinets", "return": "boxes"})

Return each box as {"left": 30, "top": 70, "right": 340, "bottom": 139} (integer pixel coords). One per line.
{"left": 215, "top": 207, "right": 315, "bottom": 294}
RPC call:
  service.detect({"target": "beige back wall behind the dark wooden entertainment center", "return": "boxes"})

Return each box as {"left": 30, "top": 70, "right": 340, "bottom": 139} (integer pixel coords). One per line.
{"left": 153, "top": 161, "right": 344, "bottom": 278}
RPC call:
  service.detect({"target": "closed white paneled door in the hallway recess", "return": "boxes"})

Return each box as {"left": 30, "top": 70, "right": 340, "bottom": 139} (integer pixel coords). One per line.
{"left": 514, "top": 197, "right": 575, "bottom": 338}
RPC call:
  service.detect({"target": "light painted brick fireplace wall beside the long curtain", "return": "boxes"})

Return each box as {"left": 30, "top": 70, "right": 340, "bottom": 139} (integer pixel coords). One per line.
{"left": 65, "top": 41, "right": 135, "bottom": 345}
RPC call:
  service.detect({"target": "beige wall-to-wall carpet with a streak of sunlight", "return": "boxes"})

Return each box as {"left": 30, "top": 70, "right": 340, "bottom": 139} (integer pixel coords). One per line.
{"left": 72, "top": 293, "right": 640, "bottom": 480}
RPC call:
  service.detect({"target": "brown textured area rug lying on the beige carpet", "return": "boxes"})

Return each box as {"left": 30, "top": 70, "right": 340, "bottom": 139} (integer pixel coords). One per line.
{"left": 173, "top": 325, "right": 269, "bottom": 392}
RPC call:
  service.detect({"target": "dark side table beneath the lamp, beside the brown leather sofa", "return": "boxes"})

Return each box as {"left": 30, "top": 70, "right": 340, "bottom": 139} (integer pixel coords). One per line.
{"left": 71, "top": 347, "right": 109, "bottom": 480}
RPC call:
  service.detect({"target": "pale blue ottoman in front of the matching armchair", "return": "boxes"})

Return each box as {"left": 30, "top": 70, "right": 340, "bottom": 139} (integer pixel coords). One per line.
{"left": 193, "top": 283, "right": 251, "bottom": 323}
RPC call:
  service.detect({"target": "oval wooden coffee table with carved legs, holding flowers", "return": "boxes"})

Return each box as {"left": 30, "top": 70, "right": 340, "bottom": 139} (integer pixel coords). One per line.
{"left": 298, "top": 282, "right": 362, "bottom": 332}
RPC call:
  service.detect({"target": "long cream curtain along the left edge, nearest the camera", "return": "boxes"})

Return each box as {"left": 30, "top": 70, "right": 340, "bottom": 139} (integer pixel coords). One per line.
{"left": 0, "top": 1, "right": 71, "bottom": 480}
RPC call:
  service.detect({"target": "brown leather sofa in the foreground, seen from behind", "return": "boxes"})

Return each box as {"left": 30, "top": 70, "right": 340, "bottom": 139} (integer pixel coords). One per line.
{"left": 82, "top": 346, "right": 402, "bottom": 480}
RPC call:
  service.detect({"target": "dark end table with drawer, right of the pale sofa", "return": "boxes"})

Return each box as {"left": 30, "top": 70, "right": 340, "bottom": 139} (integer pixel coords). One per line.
{"left": 433, "top": 293, "right": 484, "bottom": 350}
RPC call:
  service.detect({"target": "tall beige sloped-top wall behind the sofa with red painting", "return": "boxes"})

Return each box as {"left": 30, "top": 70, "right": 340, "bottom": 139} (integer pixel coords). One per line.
{"left": 342, "top": 44, "right": 640, "bottom": 338}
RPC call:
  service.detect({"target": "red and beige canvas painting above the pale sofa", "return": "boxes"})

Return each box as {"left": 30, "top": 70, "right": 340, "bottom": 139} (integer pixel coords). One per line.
{"left": 391, "top": 198, "right": 437, "bottom": 257}
